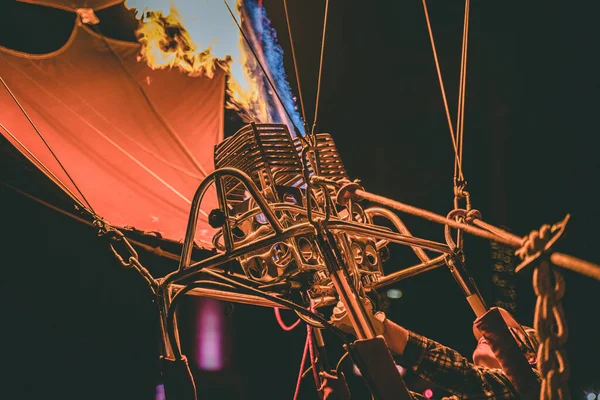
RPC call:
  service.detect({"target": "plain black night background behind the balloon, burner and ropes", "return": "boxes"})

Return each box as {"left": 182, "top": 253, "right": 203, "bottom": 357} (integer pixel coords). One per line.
{"left": 0, "top": 0, "right": 600, "bottom": 399}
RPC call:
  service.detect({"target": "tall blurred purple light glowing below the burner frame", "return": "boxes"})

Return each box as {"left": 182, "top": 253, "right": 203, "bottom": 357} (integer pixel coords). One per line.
{"left": 196, "top": 299, "right": 224, "bottom": 371}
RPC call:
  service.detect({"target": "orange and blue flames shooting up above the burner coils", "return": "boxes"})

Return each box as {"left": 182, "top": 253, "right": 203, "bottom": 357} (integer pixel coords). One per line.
{"left": 126, "top": 0, "right": 302, "bottom": 134}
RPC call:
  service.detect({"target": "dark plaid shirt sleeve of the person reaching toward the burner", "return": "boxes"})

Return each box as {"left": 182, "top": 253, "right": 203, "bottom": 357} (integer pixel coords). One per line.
{"left": 401, "top": 331, "right": 517, "bottom": 399}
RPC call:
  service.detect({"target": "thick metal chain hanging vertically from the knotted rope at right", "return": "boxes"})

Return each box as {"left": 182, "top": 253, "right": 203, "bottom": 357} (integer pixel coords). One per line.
{"left": 533, "top": 259, "right": 570, "bottom": 400}
